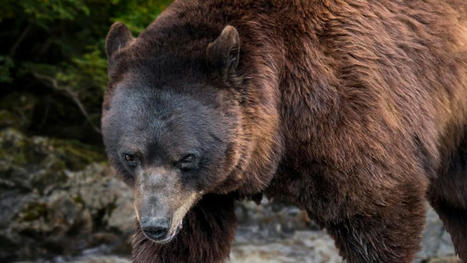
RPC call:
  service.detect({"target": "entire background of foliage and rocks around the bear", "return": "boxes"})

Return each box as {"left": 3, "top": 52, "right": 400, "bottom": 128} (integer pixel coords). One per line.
{"left": 0, "top": 0, "right": 457, "bottom": 263}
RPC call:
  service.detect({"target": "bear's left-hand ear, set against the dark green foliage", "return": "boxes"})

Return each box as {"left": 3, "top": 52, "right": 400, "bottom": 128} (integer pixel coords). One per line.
{"left": 105, "top": 22, "right": 134, "bottom": 59}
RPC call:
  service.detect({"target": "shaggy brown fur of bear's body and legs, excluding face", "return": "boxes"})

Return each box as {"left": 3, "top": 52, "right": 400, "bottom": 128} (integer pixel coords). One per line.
{"left": 104, "top": 0, "right": 467, "bottom": 263}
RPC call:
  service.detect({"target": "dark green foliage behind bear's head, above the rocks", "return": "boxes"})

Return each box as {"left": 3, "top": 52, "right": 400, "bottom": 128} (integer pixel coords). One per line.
{"left": 0, "top": 0, "right": 171, "bottom": 143}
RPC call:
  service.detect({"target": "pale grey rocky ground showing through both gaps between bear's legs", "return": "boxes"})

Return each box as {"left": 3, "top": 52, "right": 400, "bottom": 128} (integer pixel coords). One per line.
{"left": 230, "top": 199, "right": 459, "bottom": 263}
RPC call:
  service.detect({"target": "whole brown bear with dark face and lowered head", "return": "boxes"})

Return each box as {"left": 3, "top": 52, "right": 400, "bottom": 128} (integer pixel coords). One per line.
{"left": 102, "top": 0, "right": 467, "bottom": 263}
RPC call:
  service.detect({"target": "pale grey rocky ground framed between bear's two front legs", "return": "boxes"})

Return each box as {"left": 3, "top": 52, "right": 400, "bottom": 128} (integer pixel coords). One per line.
{"left": 230, "top": 199, "right": 342, "bottom": 263}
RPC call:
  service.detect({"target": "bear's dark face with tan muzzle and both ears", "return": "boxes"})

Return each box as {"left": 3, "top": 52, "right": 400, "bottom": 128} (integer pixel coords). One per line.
{"left": 102, "top": 24, "right": 242, "bottom": 243}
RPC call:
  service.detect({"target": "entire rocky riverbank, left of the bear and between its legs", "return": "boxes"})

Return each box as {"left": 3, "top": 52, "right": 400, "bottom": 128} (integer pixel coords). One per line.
{"left": 0, "top": 127, "right": 457, "bottom": 263}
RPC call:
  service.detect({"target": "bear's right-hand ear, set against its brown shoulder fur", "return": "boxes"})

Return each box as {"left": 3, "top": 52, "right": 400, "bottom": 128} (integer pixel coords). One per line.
{"left": 206, "top": 25, "right": 240, "bottom": 80}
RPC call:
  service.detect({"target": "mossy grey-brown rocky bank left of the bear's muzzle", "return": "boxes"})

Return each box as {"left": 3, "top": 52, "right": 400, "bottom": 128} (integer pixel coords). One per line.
{"left": 0, "top": 128, "right": 134, "bottom": 261}
